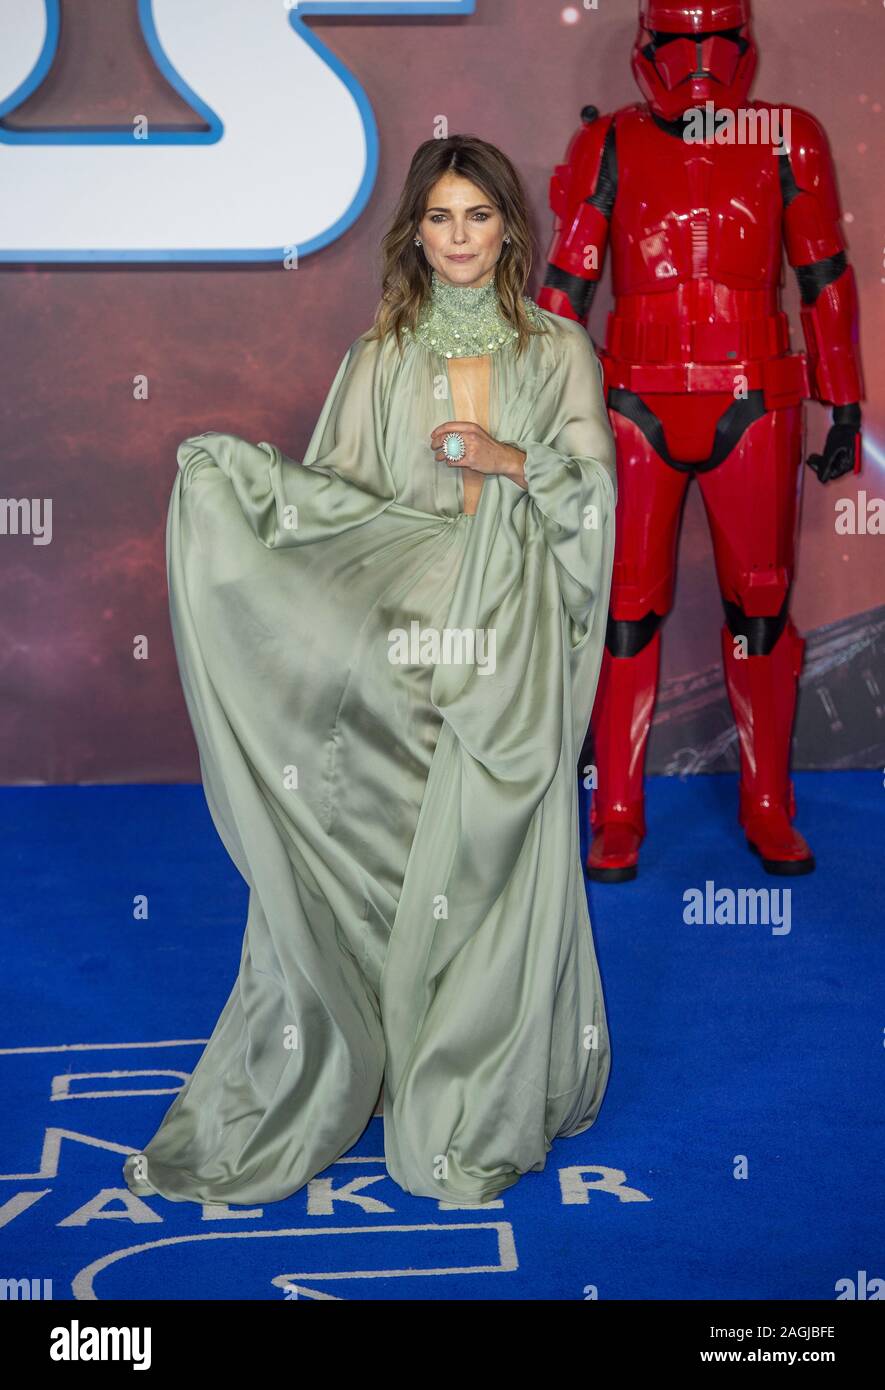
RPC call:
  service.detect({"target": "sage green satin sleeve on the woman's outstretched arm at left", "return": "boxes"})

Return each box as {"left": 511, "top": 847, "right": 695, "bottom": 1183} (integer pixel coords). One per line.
{"left": 178, "top": 338, "right": 396, "bottom": 549}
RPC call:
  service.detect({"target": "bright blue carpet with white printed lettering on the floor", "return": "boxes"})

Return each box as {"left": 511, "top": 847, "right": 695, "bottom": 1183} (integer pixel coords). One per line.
{"left": 0, "top": 773, "right": 885, "bottom": 1300}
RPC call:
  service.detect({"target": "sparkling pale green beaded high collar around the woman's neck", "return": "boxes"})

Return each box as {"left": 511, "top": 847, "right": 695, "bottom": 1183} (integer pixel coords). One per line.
{"left": 406, "top": 270, "right": 543, "bottom": 357}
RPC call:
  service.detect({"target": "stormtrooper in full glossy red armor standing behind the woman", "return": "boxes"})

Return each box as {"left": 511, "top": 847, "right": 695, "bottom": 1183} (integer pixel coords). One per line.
{"left": 538, "top": 0, "right": 864, "bottom": 881}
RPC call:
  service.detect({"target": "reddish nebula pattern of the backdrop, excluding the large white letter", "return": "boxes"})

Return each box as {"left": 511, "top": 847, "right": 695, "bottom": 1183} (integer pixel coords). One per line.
{"left": 0, "top": 0, "right": 885, "bottom": 783}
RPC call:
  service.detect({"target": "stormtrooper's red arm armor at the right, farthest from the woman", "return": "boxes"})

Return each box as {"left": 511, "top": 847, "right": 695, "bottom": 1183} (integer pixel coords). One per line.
{"left": 781, "top": 107, "right": 864, "bottom": 406}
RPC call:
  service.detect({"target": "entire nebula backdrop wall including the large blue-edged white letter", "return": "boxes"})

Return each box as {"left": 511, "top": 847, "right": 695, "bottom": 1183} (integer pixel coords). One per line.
{"left": 0, "top": 0, "right": 885, "bottom": 784}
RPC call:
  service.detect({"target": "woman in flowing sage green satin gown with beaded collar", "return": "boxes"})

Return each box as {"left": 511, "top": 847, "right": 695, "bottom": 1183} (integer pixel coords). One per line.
{"left": 124, "top": 136, "right": 615, "bottom": 1205}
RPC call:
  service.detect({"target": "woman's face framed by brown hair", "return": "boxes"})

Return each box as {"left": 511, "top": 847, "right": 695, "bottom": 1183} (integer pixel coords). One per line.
{"left": 418, "top": 174, "right": 507, "bottom": 289}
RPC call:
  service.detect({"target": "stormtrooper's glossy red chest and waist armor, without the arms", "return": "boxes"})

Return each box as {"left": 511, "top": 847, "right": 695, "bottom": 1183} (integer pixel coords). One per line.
{"left": 603, "top": 107, "right": 809, "bottom": 406}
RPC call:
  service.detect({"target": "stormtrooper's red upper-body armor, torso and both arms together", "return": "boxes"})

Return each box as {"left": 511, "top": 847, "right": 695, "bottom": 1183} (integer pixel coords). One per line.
{"left": 539, "top": 101, "right": 863, "bottom": 410}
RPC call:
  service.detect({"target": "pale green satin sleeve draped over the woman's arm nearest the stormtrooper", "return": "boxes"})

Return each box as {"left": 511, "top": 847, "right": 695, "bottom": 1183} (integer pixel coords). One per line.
{"left": 518, "top": 316, "right": 617, "bottom": 648}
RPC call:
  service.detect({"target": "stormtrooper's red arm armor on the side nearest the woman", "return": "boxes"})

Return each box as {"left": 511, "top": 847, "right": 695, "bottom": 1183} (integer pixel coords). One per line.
{"left": 538, "top": 107, "right": 617, "bottom": 324}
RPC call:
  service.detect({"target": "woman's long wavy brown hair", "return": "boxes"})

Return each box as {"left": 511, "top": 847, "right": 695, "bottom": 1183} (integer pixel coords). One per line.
{"left": 364, "top": 135, "right": 546, "bottom": 353}
